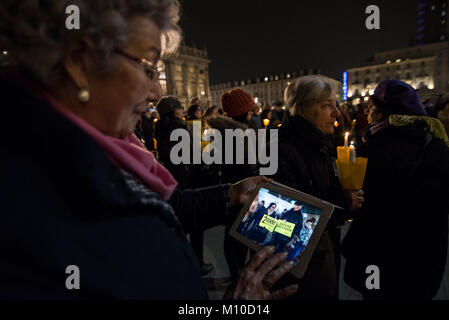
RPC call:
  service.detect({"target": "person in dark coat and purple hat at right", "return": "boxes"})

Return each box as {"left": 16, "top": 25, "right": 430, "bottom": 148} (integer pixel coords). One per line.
{"left": 343, "top": 80, "right": 449, "bottom": 299}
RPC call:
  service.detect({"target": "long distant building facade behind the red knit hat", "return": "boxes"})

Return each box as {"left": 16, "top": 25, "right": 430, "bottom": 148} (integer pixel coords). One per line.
{"left": 211, "top": 69, "right": 342, "bottom": 106}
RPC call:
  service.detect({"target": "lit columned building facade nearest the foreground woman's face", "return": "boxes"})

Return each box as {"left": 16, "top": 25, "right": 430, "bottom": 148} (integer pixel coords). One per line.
{"left": 158, "top": 46, "right": 211, "bottom": 108}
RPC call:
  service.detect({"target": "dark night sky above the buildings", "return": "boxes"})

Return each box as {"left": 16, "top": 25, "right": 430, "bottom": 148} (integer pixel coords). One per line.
{"left": 181, "top": 0, "right": 418, "bottom": 84}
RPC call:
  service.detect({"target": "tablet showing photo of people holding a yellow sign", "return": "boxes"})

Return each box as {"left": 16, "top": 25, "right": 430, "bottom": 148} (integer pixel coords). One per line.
{"left": 229, "top": 182, "right": 335, "bottom": 278}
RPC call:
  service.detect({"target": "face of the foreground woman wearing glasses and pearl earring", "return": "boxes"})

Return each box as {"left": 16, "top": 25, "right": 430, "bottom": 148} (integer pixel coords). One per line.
{"left": 66, "top": 16, "right": 162, "bottom": 137}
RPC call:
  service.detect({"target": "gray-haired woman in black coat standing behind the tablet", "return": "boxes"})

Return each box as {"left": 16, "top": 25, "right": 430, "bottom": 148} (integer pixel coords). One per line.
{"left": 274, "top": 76, "right": 363, "bottom": 299}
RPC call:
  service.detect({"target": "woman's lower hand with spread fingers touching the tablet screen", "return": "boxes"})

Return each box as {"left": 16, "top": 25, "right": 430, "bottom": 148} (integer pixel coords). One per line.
{"left": 224, "top": 247, "right": 298, "bottom": 300}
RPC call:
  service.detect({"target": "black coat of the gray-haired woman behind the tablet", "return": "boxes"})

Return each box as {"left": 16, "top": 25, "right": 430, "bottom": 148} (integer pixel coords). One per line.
{"left": 273, "top": 116, "right": 345, "bottom": 299}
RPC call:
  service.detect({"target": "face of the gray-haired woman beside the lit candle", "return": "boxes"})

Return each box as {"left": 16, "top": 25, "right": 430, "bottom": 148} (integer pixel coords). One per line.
{"left": 302, "top": 92, "right": 340, "bottom": 134}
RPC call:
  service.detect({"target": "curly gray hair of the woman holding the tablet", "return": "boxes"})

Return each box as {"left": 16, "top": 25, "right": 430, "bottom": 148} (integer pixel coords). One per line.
{"left": 0, "top": 0, "right": 181, "bottom": 84}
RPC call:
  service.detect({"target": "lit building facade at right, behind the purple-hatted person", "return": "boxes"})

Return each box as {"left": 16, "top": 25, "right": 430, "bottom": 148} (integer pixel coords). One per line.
{"left": 347, "top": 41, "right": 449, "bottom": 100}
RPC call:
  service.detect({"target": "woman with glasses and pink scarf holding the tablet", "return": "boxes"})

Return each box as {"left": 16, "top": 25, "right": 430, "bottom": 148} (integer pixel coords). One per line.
{"left": 0, "top": 0, "right": 296, "bottom": 299}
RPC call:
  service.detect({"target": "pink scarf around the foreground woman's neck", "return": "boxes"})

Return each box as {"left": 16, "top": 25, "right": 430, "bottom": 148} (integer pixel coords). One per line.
{"left": 18, "top": 78, "right": 177, "bottom": 200}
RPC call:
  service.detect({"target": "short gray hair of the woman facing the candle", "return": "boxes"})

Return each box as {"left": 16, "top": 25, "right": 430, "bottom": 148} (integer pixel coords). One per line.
{"left": 284, "top": 75, "right": 336, "bottom": 115}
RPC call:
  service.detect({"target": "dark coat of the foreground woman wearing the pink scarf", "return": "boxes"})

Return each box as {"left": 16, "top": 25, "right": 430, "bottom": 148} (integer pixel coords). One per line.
{"left": 0, "top": 77, "right": 226, "bottom": 299}
